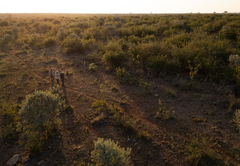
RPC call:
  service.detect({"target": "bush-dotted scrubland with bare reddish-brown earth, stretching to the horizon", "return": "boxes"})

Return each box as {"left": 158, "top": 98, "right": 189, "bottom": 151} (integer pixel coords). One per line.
{"left": 0, "top": 13, "right": 240, "bottom": 165}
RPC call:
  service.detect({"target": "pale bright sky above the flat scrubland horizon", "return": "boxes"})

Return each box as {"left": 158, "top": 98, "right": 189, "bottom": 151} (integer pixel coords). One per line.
{"left": 0, "top": 0, "right": 240, "bottom": 14}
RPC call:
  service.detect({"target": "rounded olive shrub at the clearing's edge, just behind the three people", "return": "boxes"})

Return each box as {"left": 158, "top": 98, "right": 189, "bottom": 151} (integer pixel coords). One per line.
{"left": 62, "top": 34, "right": 84, "bottom": 54}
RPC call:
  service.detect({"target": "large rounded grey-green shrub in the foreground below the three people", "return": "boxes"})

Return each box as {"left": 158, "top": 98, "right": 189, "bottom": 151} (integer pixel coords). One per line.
{"left": 19, "top": 91, "right": 61, "bottom": 151}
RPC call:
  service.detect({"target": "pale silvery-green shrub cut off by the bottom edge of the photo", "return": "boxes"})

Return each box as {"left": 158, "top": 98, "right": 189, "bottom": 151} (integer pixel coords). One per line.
{"left": 91, "top": 138, "right": 131, "bottom": 166}
